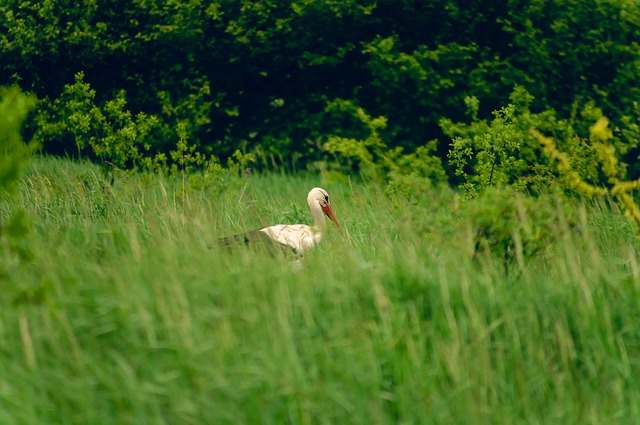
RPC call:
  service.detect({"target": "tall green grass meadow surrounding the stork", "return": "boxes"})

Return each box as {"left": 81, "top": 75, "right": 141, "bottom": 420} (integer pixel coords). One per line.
{"left": 0, "top": 158, "right": 640, "bottom": 425}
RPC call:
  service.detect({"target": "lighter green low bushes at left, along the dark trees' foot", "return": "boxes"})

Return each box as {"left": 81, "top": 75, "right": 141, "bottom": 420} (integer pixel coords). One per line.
{"left": 33, "top": 72, "right": 252, "bottom": 187}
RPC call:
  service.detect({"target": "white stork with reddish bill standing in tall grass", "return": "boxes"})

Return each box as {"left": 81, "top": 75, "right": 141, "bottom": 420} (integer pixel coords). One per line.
{"left": 218, "top": 187, "right": 341, "bottom": 255}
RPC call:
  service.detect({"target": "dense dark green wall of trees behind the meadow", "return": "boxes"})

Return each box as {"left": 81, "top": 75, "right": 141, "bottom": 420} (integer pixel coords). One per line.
{"left": 0, "top": 0, "right": 640, "bottom": 176}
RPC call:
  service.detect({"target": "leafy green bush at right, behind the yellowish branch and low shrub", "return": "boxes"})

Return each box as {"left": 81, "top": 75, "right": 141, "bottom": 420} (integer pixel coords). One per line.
{"left": 440, "top": 87, "right": 640, "bottom": 197}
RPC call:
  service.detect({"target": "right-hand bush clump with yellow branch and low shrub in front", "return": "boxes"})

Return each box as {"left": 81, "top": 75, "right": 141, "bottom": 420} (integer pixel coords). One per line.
{"left": 441, "top": 88, "right": 640, "bottom": 265}
